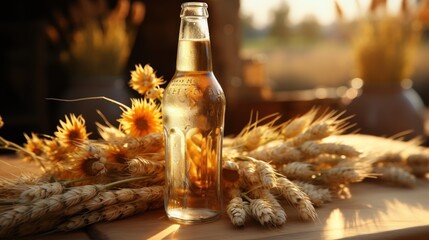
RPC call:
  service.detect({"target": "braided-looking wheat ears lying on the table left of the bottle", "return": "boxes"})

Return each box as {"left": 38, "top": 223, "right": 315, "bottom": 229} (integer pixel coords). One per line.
{"left": 0, "top": 179, "right": 164, "bottom": 237}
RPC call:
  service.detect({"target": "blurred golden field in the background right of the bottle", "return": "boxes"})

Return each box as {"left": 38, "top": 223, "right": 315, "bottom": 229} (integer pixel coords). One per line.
{"left": 241, "top": 38, "right": 429, "bottom": 105}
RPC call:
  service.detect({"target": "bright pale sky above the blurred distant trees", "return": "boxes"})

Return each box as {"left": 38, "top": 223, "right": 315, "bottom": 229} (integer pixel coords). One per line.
{"left": 240, "top": 0, "right": 408, "bottom": 28}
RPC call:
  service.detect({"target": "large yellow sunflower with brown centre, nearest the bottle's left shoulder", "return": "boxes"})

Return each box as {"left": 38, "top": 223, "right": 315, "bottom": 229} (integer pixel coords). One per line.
{"left": 118, "top": 99, "right": 162, "bottom": 137}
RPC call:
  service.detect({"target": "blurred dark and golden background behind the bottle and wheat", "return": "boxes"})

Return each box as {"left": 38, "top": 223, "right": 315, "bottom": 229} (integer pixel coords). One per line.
{"left": 0, "top": 0, "right": 429, "bottom": 143}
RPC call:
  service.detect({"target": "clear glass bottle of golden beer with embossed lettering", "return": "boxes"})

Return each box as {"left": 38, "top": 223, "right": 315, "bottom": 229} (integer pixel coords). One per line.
{"left": 162, "top": 2, "right": 226, "bottom": 224}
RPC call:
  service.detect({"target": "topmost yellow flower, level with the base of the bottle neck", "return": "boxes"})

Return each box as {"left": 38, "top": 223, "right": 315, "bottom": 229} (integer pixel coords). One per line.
{"left": 129, "top": 64, "right": 165, "bottom": 95}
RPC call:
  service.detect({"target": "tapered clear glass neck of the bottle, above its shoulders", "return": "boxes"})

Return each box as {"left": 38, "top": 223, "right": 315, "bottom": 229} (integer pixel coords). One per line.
{"left": 176, "top": 3, "right": 212, "bottom": 72}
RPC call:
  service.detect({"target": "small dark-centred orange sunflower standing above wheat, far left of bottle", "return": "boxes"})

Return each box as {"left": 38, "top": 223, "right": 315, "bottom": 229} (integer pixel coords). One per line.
{"left": 55, "top": 114, "right": 89, "bottom": 147}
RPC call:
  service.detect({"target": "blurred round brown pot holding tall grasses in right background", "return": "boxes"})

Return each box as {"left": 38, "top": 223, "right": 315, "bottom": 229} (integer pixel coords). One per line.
{"left": 346, "top": 83, "right": 425, "bottom": 139}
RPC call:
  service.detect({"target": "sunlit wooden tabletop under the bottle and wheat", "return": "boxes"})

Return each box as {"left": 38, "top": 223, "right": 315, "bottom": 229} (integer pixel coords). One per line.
{"left": 0, "top": 156, "right": 429, "bottom": 240}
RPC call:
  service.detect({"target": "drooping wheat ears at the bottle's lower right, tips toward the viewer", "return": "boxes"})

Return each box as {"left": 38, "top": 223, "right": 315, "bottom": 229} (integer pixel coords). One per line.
{"left": 224, "top": 156, "right": 317, "bottom": 227}
